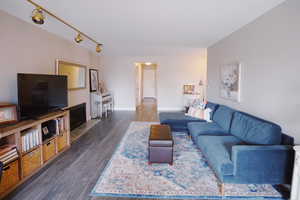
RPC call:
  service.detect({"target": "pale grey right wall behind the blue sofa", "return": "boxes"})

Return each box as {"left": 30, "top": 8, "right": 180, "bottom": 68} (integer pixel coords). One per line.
{"left": 208, "top": 0, "right": 300, "bottom": 143}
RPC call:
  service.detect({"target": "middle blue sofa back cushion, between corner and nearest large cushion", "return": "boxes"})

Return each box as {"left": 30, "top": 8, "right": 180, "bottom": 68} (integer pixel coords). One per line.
{"left": 213, "top": 105, "right": 235, "bottom": 132}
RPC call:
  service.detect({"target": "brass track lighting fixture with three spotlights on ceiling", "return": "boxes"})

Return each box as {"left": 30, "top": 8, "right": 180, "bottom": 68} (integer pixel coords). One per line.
{"left": 27, "top": 0, "right": 103, "bottom": 53}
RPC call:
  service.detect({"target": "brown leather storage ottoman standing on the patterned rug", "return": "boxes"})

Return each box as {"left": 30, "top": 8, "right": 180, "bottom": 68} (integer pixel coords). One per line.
{"left": 148, "top": 125, "right": 174, "bottom": 165}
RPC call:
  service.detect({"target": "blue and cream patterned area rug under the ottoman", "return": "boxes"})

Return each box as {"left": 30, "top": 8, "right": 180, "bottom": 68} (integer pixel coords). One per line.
{"left": 91, "top": 122, "right": 283, "bottom": 200}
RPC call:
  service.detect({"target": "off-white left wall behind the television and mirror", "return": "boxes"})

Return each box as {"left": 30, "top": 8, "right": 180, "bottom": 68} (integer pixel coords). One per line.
{"left": 0, "top": 11, "right": 100, "bottom": 119}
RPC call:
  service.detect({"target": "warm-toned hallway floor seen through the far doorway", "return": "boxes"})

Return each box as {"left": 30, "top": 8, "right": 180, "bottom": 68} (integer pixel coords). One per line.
{"left": 136, "top": 98, "right": 159, "bottom": 122}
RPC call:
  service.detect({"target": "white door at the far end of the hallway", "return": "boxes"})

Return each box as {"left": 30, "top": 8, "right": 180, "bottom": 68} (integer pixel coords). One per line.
{"left": 143, "top": 69, "right": 156, "bottom": 98}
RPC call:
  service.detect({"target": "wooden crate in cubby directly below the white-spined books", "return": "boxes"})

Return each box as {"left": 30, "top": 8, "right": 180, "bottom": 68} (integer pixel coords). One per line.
{"left": 22, "top": 147, "right": 42, "bottom": 177}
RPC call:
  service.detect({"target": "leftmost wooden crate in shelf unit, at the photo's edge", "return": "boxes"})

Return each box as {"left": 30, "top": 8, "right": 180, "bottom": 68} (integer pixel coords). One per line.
{"left": 0, "top": 160, "right": 20, "bottom": 194}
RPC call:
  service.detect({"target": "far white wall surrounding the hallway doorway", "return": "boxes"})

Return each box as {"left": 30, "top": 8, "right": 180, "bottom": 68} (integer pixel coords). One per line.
{"left": 101, "top": 47, "right": 206, "bottom": 110}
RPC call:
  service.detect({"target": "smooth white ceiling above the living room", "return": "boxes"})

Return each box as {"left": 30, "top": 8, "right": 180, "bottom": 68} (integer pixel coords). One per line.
{"left": 0, "top": 0, "right": 284, "bottom": 49}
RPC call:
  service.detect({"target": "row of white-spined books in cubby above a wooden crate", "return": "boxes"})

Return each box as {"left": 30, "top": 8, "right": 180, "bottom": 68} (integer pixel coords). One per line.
{"left": 22, "top": 128, "right": 41, "bottom": 152}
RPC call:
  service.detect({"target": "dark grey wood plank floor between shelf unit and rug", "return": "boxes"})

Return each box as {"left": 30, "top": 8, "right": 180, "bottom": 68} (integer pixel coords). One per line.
{"left": 6, "top": 111, "right": 156, "bottom": 200}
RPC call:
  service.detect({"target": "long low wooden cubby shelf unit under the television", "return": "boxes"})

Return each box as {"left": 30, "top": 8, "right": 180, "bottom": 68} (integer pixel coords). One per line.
{"left": 0, "top": 111, "right": 71, "bottom": 199}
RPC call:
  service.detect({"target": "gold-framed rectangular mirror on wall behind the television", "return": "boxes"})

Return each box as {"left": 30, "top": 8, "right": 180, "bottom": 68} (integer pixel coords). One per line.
{"left": 56, "top": 60, "right": 87, "bottom": 90}
